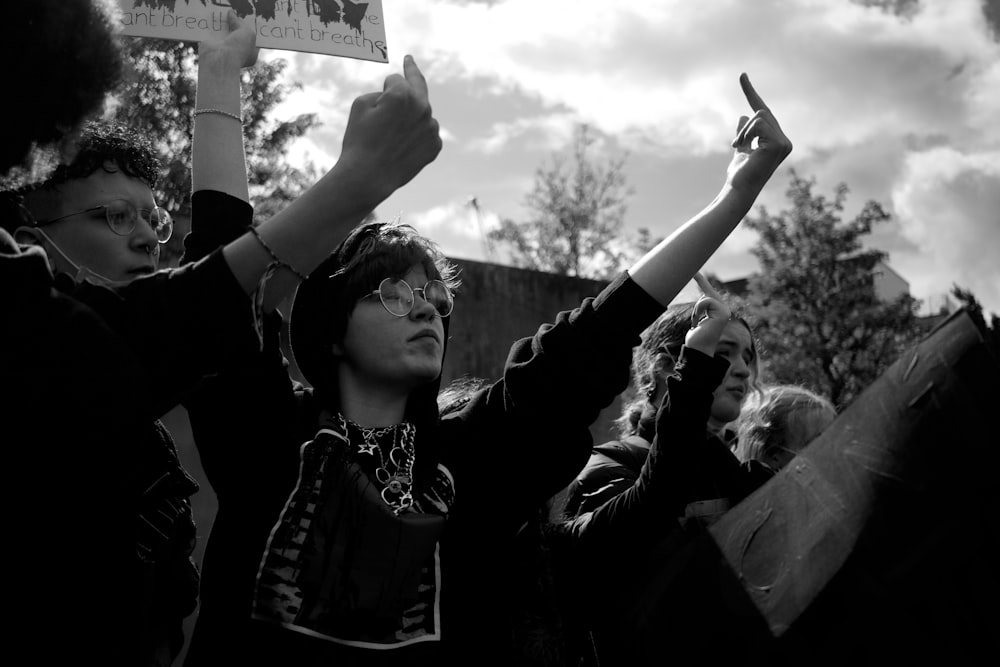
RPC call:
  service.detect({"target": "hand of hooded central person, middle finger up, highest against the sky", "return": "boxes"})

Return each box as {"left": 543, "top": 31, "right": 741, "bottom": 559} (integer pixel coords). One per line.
{"left": 727, "top": 73, "right": 792, "bottom": 195}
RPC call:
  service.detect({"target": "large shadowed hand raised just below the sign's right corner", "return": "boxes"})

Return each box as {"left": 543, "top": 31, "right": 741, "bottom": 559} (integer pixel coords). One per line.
{"left": 338, "top": 56, "right": 441, "bottom": 204}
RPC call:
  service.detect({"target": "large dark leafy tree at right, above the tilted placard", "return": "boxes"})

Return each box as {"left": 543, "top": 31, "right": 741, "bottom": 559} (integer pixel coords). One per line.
{"left": 746, "top": 171, "right": 923, "bottom": 406}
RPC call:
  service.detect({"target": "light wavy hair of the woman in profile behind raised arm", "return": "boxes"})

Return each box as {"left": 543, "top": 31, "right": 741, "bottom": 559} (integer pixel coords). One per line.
{"left": 615, "top": 301, "right": 760, "bottom": 437}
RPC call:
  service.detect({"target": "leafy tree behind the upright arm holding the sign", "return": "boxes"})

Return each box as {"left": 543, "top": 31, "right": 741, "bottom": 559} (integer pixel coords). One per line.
{"left": 111, "top": 38, "right": 318, "bottom": 266}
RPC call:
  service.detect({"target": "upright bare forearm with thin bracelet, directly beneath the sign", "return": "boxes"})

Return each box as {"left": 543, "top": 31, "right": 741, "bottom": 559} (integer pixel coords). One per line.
{"left": 191, "top": 50, "right": 250, "bottom": 202}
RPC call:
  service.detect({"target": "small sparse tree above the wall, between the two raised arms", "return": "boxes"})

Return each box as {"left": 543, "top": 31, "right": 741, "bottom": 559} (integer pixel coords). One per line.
{"left": 488, "top": 125, "right": 657, "bottom": 278}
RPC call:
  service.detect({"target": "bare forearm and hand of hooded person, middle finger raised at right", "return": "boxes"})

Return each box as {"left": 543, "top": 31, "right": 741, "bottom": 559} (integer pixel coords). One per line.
{"left": 629, "top": 74, "right": 792, "bottom": 306}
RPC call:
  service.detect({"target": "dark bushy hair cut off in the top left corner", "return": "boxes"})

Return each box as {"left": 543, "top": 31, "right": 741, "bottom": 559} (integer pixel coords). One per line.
{"left": 0, "top": 0, "right": 122, "bottom": 173}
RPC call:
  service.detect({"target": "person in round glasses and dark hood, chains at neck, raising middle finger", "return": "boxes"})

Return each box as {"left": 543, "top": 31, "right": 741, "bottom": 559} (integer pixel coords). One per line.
{"left": 178, "top": 30, "right": 791, "bottom": 656}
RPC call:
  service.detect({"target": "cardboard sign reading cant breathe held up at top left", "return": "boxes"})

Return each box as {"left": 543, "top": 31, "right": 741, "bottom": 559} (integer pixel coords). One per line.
{"left": 118, "top": 0, "right": 389, "bottom": 63}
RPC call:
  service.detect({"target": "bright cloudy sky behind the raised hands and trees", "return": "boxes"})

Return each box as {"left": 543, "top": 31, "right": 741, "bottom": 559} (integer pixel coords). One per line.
{"left": 262, "top": 0, "right": 1000, "bottom": 314}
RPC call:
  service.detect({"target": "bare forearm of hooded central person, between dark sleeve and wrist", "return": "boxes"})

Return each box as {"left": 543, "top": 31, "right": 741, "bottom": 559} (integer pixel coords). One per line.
{"left": 629, "top": 183, "right": 760, "bottom": 306}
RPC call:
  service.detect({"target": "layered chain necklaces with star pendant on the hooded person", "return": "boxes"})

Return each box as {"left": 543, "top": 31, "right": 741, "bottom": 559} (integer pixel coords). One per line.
{"left": 337, "top": 414, "right": 417, "bottom": 514}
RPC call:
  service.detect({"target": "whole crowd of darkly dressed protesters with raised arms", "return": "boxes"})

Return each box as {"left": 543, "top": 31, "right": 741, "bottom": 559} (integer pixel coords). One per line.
{"left": 11, "top": 0, "right": 940, "bottom": 666}
